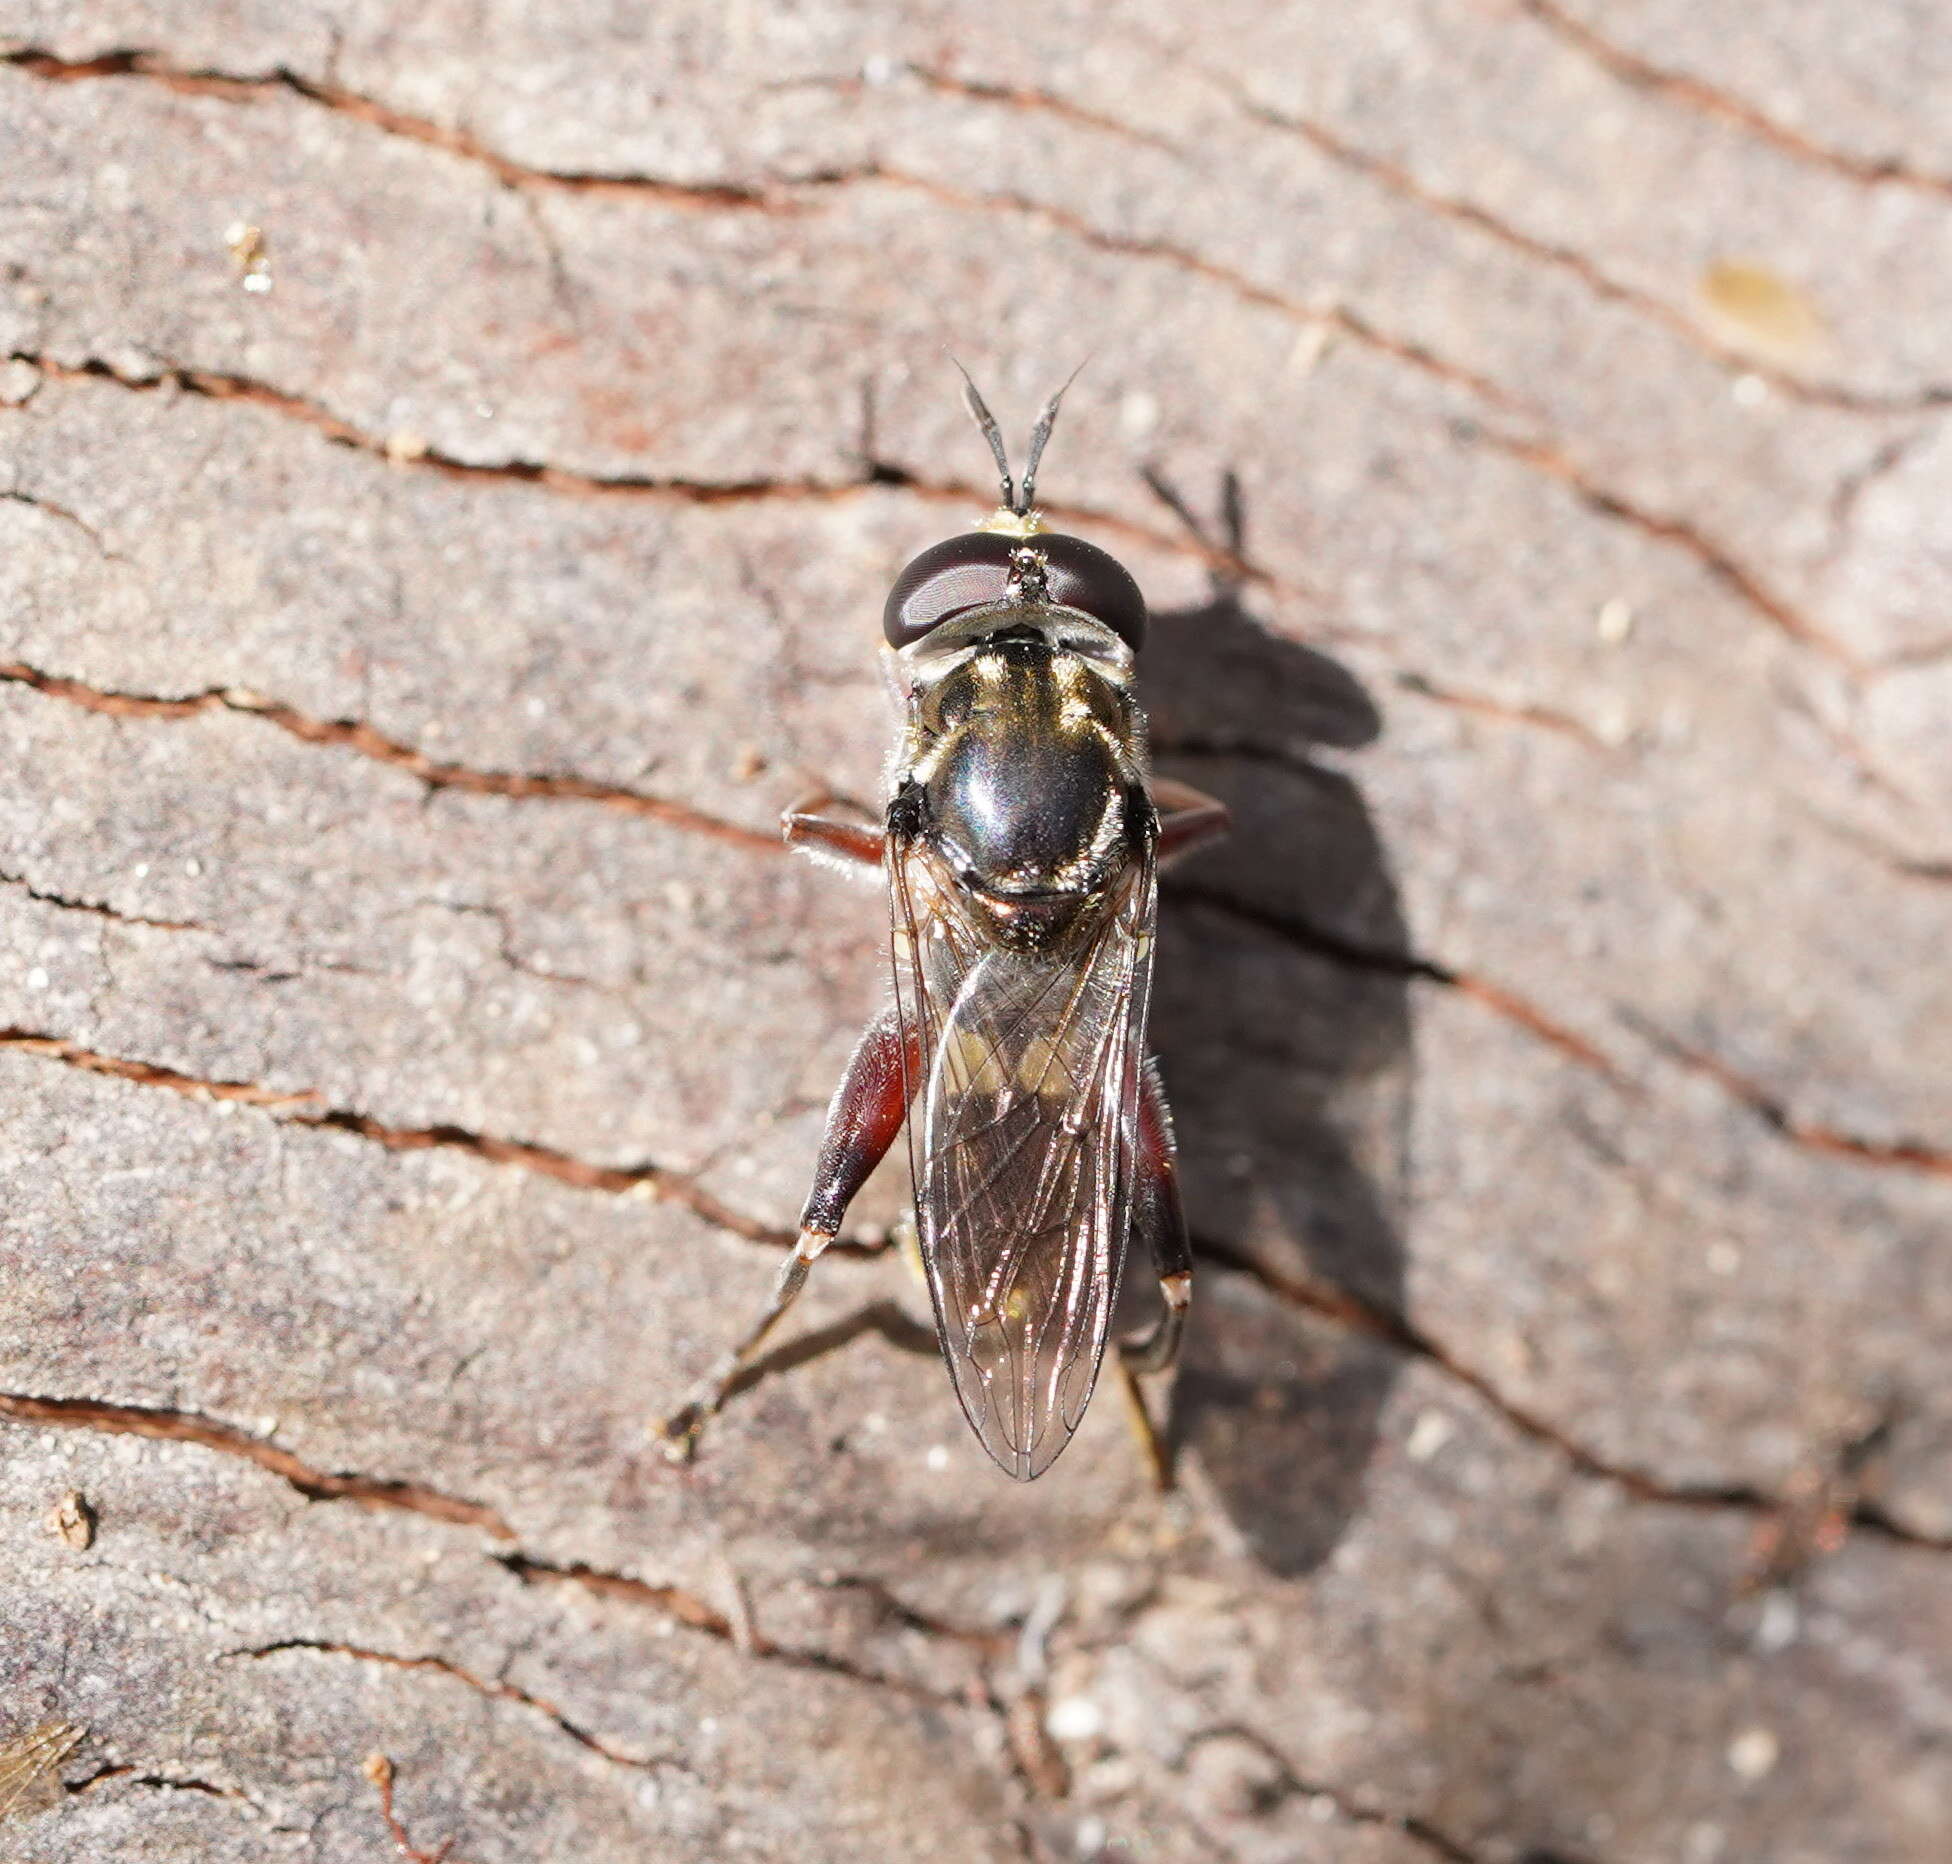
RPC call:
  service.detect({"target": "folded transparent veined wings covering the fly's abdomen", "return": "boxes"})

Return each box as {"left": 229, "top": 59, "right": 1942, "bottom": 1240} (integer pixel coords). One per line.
{"left": 888, "top": 841, "right": 1156, "bottom": 1481}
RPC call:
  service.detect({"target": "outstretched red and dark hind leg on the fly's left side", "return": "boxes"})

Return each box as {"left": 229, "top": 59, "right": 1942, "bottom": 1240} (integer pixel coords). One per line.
{"left": 658, "top": 1005, "right": 915, "bottom": 1462}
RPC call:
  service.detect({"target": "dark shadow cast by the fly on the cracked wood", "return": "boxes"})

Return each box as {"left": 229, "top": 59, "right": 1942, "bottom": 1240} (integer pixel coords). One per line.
{"left": 1140, "top": 476, "right": 1413, "bottom": 1575}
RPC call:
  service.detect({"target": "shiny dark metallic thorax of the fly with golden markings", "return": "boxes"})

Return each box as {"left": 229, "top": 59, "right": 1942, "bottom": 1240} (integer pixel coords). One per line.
{"left": 892, "top": 601, "right": 1152, "bottom": 949}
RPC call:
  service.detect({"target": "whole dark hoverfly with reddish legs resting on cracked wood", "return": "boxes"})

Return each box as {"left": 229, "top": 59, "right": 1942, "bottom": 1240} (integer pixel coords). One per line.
{"left": 664, "top": 373, "right": 1228, "bottom": 1481}
